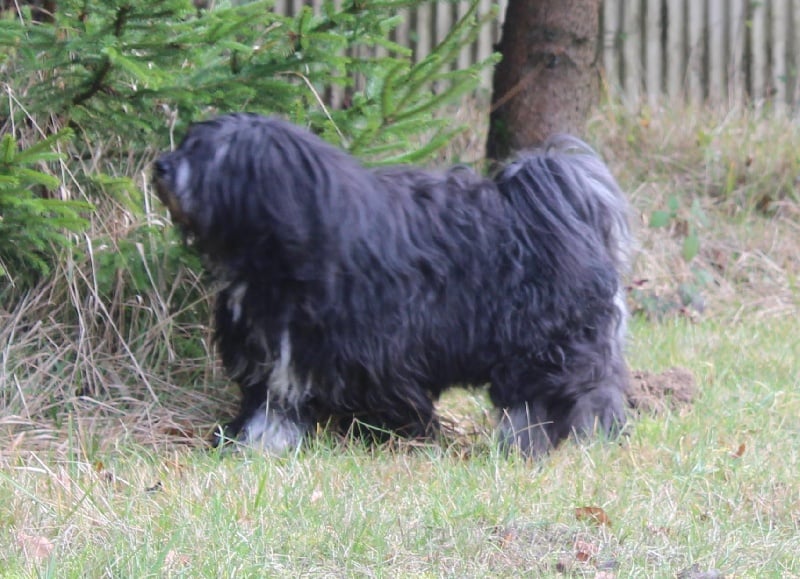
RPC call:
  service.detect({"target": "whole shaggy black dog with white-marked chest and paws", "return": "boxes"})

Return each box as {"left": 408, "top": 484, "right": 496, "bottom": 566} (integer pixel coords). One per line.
{"left": 155, "top": 114, "right": 630, "bottom": 454}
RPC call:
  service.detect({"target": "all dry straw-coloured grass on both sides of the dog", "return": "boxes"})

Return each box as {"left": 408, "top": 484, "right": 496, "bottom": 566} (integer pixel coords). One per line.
{"left": 0, "top": 102, "right": 800, "bottom": 460}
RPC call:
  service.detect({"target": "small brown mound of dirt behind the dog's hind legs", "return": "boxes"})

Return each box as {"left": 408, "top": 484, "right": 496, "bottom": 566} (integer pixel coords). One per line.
{"left": 628, "top": 368, "right": 698, "bottom": 415}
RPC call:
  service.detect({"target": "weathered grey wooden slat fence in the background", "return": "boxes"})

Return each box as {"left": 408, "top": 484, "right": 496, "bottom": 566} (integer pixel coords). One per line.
{"left": 276, "top": 0, "right": 800, "bottom": 110}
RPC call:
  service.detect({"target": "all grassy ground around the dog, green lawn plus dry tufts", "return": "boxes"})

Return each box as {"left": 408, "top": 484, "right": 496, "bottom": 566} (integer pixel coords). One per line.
{"left": 0, "top": 105, "right": 800, "bottom": 577}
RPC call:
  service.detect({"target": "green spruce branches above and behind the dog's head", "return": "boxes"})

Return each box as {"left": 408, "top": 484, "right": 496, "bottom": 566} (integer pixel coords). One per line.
{"left": 0, "top": 0, "right": 494, "bottom": 296}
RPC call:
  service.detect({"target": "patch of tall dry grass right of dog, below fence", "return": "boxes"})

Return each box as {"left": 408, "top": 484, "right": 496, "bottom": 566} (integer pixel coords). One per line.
{"left": 590, "top": 106, "right": 800, "bottom": 317}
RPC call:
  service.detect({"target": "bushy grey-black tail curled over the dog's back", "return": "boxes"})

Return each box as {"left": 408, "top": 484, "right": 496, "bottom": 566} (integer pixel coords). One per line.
{"left": 495, "top": 135, "right": 633, "bottom": 276}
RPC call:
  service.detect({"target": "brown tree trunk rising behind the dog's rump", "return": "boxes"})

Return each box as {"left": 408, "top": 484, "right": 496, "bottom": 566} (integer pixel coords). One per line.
{"left": 486, "top": 0, "right": 600, "bottom": 160}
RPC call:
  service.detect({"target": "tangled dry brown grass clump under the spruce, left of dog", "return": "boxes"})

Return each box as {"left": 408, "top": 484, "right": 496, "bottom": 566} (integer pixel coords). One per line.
{"left": 0, "top": 264, "right": 231, "bottom": 452}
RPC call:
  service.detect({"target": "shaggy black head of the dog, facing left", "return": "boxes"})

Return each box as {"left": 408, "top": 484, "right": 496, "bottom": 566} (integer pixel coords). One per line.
{"left": 153, "top": 113, "right": 316, "bottom": 256}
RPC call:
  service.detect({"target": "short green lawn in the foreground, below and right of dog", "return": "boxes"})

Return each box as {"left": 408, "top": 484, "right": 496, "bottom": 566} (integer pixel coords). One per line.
{"left": 0, "top": 319, "right": 800, "bottom": 577}
